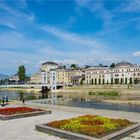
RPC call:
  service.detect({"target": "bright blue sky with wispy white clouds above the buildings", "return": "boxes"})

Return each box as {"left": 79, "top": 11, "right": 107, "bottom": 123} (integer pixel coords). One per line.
{"left": 0, "top": 0, "right": 140, "bottom": 75}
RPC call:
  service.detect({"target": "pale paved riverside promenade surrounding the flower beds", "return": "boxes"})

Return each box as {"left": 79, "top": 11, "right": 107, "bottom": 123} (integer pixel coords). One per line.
{"left": 0, "top": 103, "right": 140, "bottom": 140}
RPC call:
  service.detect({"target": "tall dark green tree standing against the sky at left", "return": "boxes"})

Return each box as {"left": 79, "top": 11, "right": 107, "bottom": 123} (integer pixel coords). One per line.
{"left": 18, "top": 65, "right": 26, "bottom": 81}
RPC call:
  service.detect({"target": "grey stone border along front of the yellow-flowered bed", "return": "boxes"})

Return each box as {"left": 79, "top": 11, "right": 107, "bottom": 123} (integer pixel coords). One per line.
{"left": 35, "top": 124, "right": 140, "bottom": 140}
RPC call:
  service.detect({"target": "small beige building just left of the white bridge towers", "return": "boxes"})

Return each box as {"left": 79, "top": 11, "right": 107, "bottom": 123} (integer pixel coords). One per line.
{"left": 30, "top": 72, "right": 42, "bottom": 84}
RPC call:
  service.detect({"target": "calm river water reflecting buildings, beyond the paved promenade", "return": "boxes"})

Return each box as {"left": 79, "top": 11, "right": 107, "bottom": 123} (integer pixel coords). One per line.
{"left": 0, "top": 91, "right": 140, "bottom": 113}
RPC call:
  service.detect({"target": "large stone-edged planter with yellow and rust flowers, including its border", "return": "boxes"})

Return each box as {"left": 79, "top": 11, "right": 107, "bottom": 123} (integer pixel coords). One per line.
{"left": 35, "top": 115, "right": 140, "bottom": 140}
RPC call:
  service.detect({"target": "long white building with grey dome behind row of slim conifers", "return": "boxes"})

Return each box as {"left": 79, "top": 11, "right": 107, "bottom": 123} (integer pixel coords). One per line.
{"left": 85, "top": 61, "right": 140, "bottom": 84}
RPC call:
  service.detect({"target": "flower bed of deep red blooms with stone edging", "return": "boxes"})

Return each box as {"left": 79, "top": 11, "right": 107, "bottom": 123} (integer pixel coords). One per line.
{"left": 0, "top": 107, "right": 51, "bottom": 120}
